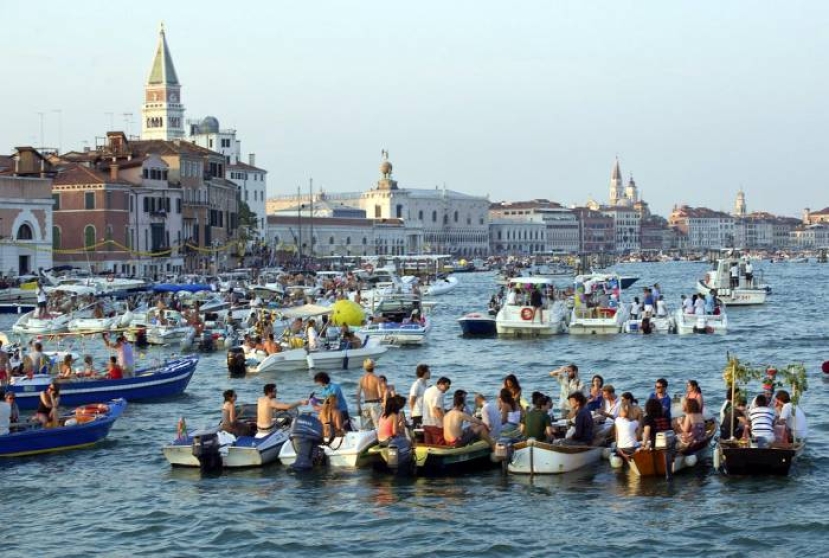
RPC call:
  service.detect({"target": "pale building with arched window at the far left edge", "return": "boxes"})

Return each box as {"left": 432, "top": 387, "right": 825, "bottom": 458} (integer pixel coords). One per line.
{"left": 0, "top": 152, "right": 52, "bottom": 276}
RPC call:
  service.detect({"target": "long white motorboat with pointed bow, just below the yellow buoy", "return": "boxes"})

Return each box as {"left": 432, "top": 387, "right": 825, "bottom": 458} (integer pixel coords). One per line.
{"left": 248, "top": 337, "right": 388, "bottom": 373}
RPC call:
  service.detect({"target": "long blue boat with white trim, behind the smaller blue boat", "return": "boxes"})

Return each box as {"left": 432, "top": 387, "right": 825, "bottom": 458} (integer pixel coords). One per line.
{"left": 6, "top": 355, "right": 199, "bottom": 409}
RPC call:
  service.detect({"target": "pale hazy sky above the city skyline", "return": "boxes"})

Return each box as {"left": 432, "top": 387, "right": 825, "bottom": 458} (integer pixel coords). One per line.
{"left": 0, "top": 0, "right": 829, "bottom": 216}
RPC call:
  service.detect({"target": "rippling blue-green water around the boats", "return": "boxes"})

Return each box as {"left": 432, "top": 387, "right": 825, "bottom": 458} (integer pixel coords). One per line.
{"left": 0, "top": 262, "right": 829, "bottom": 557}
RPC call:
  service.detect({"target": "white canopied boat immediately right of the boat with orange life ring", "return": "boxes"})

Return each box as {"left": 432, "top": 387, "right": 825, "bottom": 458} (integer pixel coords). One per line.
{"left": 568, "top": 273, "right": 629, "bottom": 335}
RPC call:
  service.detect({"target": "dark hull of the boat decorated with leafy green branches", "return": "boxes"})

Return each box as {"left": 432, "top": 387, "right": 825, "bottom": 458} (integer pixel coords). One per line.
{"left": 714, "top": 440, "right": 806, "bottom": 476}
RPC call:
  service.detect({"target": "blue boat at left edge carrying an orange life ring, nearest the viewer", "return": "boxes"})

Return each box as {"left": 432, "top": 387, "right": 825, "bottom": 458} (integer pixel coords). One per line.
{"left": 0, "top": 399, "right": 127, "bottom": 457}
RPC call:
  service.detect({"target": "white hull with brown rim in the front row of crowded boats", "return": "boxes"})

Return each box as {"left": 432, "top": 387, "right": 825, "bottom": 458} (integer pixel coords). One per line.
{"left": 507, "top": 438, "right": 604, "bottom": 475}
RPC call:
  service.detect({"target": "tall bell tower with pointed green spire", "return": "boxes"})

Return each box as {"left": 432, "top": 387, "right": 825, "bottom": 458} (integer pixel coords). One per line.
{"left": 141, "top": 23, "right": 185, "bottom": 140}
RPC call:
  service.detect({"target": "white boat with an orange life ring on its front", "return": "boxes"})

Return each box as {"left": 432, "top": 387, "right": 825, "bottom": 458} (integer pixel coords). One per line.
{"left": 495, "top": 277, "right": 566, "bottom": 335}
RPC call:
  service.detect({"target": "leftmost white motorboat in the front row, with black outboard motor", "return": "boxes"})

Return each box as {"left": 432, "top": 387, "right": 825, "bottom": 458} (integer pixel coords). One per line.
{"left": 162, "top": 405, "right": 293, "bottom": 469}
